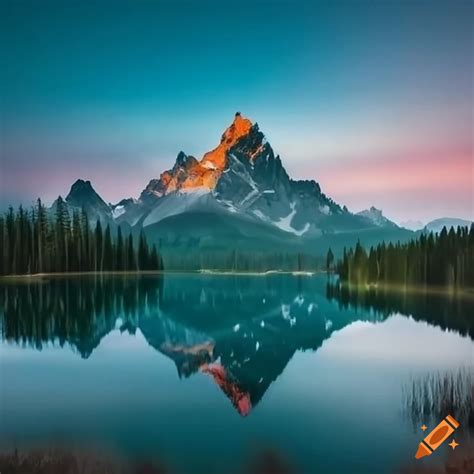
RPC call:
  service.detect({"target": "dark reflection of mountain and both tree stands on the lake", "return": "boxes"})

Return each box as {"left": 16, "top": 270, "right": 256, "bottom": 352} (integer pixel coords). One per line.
{"left": 0, "top": 275, "right": 474, "bottom": 416}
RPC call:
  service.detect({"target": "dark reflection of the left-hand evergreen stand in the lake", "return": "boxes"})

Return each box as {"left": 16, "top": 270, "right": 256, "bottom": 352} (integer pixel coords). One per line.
{"left": 0, "top": 277, "right": 162, "bottom": 358}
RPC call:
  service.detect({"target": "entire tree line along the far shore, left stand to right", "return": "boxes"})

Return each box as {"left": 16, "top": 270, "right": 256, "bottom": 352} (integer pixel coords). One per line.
{"left": 0, "top": 198, "right": 474, "bottom": 289}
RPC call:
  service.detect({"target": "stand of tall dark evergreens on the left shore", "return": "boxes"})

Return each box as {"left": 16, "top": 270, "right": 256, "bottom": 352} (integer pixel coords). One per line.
{"left": 0, "top": 204, "right": 162, "bottom": 275}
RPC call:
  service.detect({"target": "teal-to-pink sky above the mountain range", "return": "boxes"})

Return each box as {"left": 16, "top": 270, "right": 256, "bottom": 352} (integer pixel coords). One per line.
{"left": 0, "top": 0, "right": 474, "bottom": 223}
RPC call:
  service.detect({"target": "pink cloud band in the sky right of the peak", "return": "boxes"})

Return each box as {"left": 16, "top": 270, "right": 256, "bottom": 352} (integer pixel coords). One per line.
{"left": 306, "top": 154, "right": 474, "bottom": 220}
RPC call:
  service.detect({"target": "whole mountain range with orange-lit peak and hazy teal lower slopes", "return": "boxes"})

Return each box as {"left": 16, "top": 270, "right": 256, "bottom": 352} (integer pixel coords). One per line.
{"left": 53, "top": 113, "right": 462, "bottom": 255}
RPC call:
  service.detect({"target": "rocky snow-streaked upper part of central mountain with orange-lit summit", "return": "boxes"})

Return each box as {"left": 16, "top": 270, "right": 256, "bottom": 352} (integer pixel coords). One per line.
{"left": 120, "top": 113, "right": 360, "bottom": 237}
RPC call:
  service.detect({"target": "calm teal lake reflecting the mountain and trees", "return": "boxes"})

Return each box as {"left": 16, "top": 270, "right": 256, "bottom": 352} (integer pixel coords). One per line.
{"left": 0, "top": 274, "right": 474, "bottom": 474}
